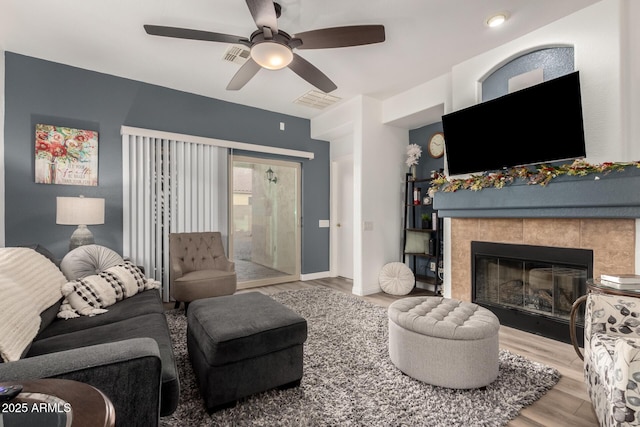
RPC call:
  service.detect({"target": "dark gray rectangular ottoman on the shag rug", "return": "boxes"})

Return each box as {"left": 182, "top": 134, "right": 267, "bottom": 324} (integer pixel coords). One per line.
{"left": 187, "top": 292, "right": 307, "bottom": 412}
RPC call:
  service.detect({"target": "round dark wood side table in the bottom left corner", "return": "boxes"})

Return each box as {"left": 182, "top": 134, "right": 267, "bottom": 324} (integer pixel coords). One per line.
{"left": 0, "top": 379, "right": 116, "bottom": 427}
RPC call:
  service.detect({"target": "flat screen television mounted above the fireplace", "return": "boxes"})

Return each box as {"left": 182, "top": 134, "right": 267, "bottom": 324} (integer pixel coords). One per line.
{"left": 442, "top": 71, "right": 586, "bottom": 175}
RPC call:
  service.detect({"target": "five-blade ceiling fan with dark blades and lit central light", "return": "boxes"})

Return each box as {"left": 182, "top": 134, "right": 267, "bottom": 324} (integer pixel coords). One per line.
{"left": 144, "top": 0, "right": 385, "bottom": 93}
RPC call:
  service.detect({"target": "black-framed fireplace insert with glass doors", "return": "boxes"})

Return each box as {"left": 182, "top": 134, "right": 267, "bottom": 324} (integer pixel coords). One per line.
{"left": 471, "top": 242, "right": 593, "bottom": 341}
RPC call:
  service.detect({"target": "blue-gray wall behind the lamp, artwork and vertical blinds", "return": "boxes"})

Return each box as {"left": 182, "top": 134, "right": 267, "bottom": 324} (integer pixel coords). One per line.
{"left": 4, "top": 52, "right": 330, "bottom": 273}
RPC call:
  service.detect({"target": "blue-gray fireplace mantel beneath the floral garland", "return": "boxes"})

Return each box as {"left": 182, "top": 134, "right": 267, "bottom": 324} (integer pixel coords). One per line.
{"left": 433, "top": 168, "right": 640, "bottom": 218}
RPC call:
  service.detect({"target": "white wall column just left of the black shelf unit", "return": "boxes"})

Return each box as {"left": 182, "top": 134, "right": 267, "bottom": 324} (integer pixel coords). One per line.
{"left": 311, "top": 96, "right": 409, "bottom": 295}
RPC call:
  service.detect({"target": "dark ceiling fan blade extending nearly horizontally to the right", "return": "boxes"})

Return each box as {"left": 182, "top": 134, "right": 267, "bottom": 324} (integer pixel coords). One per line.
{"left": 291, "top": 25, "right": 385, "bottom": 49}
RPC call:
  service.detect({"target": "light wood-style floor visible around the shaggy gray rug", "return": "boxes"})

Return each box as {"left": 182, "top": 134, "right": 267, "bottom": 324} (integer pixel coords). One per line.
{"left": 238, "top": 278, "right": 598, "bottom": 427}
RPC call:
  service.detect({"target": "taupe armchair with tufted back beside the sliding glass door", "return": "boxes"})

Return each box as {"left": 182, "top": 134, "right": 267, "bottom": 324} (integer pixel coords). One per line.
{"left": 169, "top": 231, "right": 237, "bottom": 308}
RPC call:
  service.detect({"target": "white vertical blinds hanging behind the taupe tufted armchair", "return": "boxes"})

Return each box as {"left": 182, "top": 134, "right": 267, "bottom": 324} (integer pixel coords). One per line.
{"left": 122, "top": 133, "right": 228, "bottom": 301}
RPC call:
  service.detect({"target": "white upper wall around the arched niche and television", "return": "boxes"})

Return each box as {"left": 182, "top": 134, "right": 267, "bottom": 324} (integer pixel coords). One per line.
{"left": 383, "top": 0, "right": 640, "bottom": 163}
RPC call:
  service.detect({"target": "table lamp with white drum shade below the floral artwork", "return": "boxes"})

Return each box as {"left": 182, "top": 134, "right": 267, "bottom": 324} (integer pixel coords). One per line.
{"left": 56, "top": 196, "right": 104, "bottom": 251}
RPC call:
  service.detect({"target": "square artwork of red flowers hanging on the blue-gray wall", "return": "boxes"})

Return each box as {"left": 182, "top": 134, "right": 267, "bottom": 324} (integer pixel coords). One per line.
{"left": 35, "top": 124, "right": 98, "bottom": 186}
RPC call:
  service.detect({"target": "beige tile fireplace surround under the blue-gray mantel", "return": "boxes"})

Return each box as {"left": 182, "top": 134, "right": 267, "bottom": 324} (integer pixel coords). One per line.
{"left": 450, "top": 218, "right": 636, "bottom": 340}
